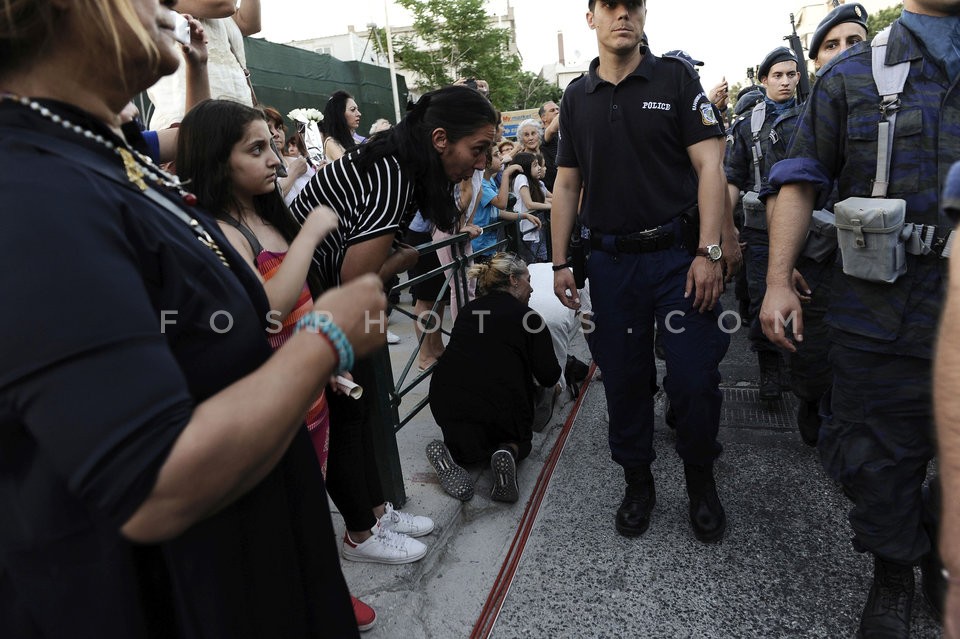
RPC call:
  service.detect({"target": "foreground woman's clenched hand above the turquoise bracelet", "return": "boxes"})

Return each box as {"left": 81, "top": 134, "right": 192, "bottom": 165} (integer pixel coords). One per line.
{"left": 313, "top": 273, "right": 387, "bottom": 358}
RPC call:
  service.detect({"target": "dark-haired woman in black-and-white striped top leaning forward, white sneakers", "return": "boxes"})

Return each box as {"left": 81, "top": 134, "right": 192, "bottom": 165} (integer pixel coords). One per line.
{"left": 291, "top": 86, "right": 497, "bottom": 563}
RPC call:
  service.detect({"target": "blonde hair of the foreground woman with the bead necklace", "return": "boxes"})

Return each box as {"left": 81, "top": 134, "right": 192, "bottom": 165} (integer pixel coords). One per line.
{"left": 0, "top": 0, "right": 160, "bottom": 86}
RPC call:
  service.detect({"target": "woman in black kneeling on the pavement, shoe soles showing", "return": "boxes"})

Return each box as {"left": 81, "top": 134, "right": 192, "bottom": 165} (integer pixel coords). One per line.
{"left": 427, "top": 253, "right": 561, "bottom": 502}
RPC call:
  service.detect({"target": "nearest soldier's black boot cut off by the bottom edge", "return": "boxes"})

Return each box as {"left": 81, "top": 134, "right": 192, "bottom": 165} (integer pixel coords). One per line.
{"left": 857, "top": 556, "right": 913, "bottom": 639}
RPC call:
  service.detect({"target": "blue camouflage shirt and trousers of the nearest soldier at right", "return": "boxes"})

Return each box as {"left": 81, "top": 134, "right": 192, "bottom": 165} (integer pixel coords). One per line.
{"left": 771, "top": 21, "right": 960, "bottom": 564}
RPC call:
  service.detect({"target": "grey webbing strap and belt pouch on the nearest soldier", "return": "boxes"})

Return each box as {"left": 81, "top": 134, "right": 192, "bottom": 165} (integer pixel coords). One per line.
{"left": 834, "top": 27, "right": 954, "bottom": 283}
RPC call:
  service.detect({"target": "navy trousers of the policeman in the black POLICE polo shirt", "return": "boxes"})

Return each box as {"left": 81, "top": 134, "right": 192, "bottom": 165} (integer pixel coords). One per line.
{"left": 587, "top": 248, "right": 730, "bottom": 469}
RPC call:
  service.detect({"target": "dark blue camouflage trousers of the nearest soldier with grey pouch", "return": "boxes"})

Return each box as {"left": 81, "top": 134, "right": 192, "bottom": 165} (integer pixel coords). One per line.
{"left": 816, "top": 348, "right": 935, "bottom": 564}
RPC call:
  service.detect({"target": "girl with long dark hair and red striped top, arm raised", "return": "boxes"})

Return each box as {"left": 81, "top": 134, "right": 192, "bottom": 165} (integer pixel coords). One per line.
{"left": 177, "top": 100, "right": 337, "bottom": 472}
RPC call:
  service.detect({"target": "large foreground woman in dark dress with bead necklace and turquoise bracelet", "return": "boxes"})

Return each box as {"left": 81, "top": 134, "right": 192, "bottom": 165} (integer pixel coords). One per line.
{"left": 0, "top": 0, "right": 386, "bottom": 639}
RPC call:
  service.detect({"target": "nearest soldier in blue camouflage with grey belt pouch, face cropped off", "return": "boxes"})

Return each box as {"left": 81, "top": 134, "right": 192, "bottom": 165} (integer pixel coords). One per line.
{"left": 761, "top": 0, "right": 960, "bottom": 637}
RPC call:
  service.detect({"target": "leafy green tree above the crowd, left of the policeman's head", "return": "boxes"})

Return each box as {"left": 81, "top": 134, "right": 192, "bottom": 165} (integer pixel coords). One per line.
{"left": 381, "top": 0, "right": 561, "bottom": 111}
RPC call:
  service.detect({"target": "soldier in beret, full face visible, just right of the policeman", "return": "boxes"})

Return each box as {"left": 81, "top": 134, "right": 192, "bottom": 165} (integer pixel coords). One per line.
{"left": 724, "top": 47, "right": 800, "bottom": 400}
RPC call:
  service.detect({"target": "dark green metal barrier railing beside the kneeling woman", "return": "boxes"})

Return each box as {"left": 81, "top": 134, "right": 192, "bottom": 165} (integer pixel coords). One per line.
{"left": 368, "top": 220, "right": 522, "bottom": 508}
